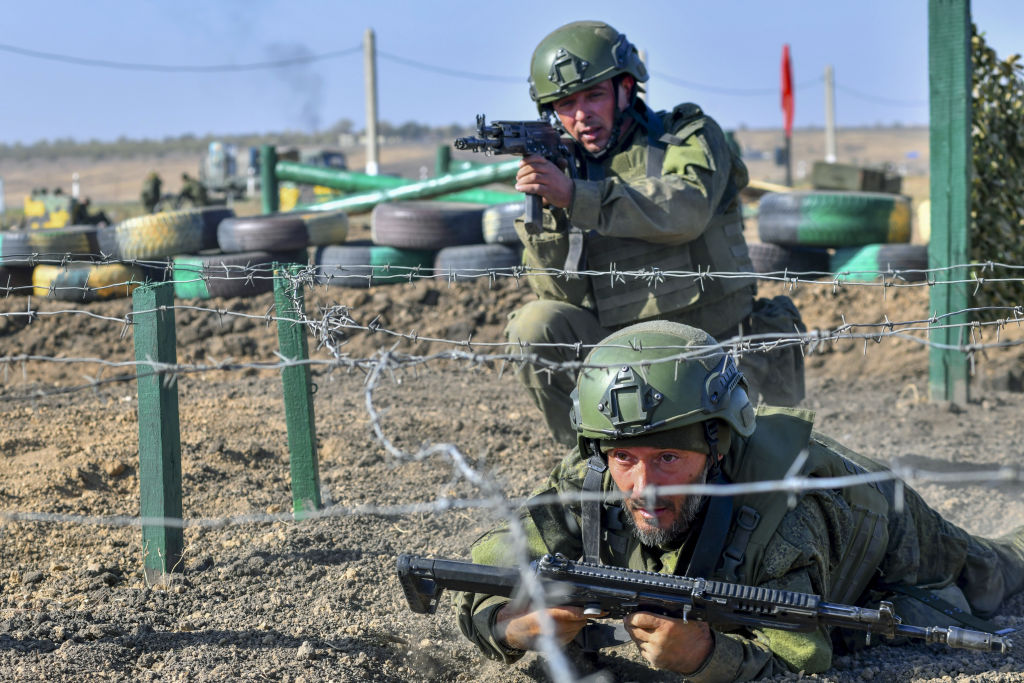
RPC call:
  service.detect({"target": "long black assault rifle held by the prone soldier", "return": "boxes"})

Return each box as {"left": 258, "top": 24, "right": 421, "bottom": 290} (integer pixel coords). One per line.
{"left": 398, "top": 555, "right": 1013, "bottom": 652}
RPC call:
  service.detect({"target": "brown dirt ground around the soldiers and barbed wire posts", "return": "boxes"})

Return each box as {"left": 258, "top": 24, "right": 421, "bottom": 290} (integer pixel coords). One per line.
{"left": 0, "top": 229, "right": 1024, "bottom": 683}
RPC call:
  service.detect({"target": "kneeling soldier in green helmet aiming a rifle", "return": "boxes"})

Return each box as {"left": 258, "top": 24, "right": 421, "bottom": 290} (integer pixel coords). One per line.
{"left": 506, "top": 22, "right": 804, "bottom": 445}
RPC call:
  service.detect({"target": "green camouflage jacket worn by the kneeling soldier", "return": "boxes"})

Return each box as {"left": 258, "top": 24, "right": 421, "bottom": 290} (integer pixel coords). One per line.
{"left": 517, "top": 104, "right": 754, "bottom": 331}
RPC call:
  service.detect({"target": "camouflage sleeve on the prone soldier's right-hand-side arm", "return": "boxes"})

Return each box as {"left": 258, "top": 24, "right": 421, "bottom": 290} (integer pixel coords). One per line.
{"left": 686, "top": 492, "right": 850, "bottom": 683}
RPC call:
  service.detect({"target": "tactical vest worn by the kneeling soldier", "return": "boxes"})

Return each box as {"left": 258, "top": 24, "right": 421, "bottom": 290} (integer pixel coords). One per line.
{"left": 584, "top": 104, "right": 754, "bottom": 329}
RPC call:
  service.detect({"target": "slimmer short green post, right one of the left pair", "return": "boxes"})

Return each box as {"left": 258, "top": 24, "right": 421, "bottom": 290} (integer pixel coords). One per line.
{"left": 273, "top": 265, "right": 321, "bottom": 519}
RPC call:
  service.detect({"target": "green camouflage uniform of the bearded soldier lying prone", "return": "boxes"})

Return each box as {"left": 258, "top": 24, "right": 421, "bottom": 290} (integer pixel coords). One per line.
{"left": 454, "top": 407, "right": 1003, "bottom": 681}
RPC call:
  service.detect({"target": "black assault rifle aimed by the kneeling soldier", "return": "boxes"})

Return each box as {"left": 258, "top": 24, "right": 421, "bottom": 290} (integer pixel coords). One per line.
{"left": 455, "top": 114, "right": 571, "bottom": 232}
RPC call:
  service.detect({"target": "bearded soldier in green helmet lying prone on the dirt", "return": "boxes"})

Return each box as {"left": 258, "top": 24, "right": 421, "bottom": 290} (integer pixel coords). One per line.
{"left": 456, "top": 321, "right": 1024, "bottom": 681}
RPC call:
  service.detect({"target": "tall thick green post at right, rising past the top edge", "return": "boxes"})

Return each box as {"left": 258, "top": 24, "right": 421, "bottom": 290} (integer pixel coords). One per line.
{"left": 928, "top": 0, "right": 972, "bottom": 402}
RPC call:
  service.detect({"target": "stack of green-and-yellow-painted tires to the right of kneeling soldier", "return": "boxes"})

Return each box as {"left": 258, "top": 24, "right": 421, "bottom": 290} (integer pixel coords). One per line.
{"left": 750, "top": 190, "right": 928, "bottom": 282}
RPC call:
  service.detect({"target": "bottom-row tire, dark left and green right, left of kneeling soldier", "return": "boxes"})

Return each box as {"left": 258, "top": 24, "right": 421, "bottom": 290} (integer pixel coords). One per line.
{"left": 313, "top": 241, "right": 435, "bottom": 289}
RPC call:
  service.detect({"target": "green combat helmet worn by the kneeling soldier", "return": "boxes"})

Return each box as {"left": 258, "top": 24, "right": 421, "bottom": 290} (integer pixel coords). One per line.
{"left": 529, "top": 22, "right": 647, "bottom": 110}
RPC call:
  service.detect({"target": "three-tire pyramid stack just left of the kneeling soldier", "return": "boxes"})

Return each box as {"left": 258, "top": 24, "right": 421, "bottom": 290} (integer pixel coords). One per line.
{"left": 313, "top": 201, "right": 521, "bottom": 288}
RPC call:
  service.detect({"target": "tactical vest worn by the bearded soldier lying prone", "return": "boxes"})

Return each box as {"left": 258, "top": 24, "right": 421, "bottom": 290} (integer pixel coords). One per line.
{"left": 581, "top": 407, "right": 891, "bottom": 604}
